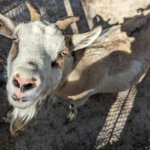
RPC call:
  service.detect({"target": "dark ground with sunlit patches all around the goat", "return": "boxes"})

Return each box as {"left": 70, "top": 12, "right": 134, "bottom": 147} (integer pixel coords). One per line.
{"left": 0, "top": 0, "right": 150, "bottom": 150}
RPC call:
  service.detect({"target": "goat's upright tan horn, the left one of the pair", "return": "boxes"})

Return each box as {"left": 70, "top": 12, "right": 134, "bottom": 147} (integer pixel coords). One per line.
{"left": 26, "top": 2, "right": 41, "bottom": 21}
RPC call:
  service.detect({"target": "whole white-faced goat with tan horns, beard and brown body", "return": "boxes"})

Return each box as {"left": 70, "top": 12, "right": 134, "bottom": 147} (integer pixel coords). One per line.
{"left": 0, "top": 3, "right": 150, "bottom": 134}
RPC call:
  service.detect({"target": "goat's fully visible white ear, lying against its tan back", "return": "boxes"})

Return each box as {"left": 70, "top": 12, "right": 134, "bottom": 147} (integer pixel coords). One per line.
{"left": 72, "top": 26, "right": 102, "bottom": 51}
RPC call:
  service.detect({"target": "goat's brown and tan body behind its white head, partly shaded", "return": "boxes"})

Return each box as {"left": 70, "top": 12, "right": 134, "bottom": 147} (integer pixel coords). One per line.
{"left": 55, "top": 15, "right": 150, "bottom": 101}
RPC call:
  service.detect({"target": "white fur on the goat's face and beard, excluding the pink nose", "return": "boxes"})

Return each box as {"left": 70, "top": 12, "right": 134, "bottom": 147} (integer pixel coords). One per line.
{"left": 7, "top": 21, "right": 65, "bottom": 124}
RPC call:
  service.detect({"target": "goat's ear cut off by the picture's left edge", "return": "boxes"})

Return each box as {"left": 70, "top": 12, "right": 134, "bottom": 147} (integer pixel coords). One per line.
{"left": 0, "top": 14, "right": 16, "bottom": 38}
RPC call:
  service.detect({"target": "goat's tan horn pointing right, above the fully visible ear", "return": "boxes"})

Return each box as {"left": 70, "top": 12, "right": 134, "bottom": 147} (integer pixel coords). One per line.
{"left": 56, "top": 16, "right": 79, "bottom": 30}
